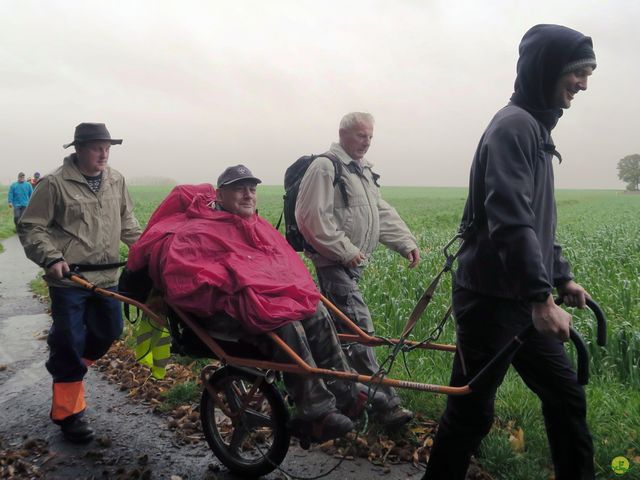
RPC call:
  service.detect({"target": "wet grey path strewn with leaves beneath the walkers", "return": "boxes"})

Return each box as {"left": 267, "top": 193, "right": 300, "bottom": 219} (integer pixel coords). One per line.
{"left": 0, "top": 236, "right": 422, "bottom": 480}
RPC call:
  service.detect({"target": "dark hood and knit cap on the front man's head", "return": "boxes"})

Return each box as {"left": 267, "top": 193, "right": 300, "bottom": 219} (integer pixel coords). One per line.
{"left": 511, "top": 24, "right": 595, "bottom": 129}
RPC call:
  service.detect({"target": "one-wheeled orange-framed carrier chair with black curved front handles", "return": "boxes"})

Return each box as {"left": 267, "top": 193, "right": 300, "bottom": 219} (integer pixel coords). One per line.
{"left": 67, "top": 272, "right": 606, "bottom": 477}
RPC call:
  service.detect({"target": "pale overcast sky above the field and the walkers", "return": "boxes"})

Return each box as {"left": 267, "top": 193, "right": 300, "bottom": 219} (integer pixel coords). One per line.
{"left": 0, "top": 0, "right": 640, "bottom": 189}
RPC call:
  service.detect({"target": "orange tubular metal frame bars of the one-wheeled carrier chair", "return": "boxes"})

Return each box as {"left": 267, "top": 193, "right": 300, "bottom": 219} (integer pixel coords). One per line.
{"left": 69, "top": 274, "right": 471, "bottom": 395}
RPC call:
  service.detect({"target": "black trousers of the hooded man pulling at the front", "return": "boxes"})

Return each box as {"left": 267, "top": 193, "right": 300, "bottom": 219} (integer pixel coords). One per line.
{"left": 423, "top": 287, "right": 594, "bottom": 480}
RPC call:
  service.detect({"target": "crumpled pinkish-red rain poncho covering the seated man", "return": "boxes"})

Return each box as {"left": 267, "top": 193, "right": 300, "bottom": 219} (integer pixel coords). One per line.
{"left": 127, "top": 184, "right": 320, "bottom": 333}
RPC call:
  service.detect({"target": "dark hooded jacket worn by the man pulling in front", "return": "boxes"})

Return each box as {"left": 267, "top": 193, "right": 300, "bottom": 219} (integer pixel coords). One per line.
{"left": 455, "top": 25, "right": 591, "bottom": 301}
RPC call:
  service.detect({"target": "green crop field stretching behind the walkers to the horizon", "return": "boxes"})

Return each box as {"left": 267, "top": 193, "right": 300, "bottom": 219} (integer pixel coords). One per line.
{"left": 0, "top": 186, "right": 640, "bottom": 480}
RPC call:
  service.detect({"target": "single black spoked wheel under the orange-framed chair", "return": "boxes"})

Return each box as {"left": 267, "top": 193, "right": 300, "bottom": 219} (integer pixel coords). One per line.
{"left": 200, "top": 367, "right": 290, "bottom": 477}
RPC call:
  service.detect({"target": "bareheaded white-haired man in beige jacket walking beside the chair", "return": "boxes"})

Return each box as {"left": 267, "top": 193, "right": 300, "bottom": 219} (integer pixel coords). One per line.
{"left": 296, "top": 112, "right": 420, "bottom": 427}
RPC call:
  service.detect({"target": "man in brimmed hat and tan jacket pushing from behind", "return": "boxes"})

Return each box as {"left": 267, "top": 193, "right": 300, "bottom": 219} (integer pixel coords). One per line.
{"left": 18, "top": 123, "right": 140, "bottom": 443}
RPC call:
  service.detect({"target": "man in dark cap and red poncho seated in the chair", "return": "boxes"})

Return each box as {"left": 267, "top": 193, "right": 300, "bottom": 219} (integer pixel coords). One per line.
{"left": 127, "top": 165, "right": 386, "bottom": 440}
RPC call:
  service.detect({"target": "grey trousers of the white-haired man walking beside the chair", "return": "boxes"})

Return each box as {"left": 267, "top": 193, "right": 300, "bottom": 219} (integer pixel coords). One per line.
{"left": 316, "top": 265, "right": 400, "bottom": 409}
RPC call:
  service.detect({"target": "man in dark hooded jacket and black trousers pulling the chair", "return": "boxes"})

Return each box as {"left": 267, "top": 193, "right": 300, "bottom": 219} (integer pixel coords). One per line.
{"left": 424, "top": 25, "right": 596, "bottom": 480}
